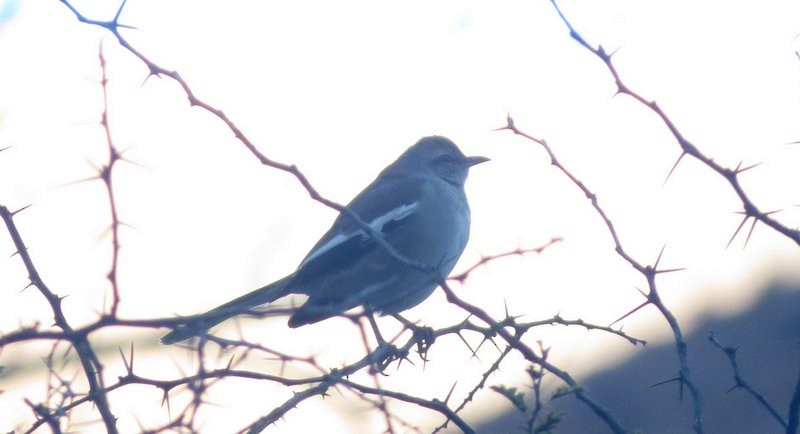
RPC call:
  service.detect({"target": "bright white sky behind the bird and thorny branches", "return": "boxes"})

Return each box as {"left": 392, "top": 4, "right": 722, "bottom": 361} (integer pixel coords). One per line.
{"left": 0, "top": 0, "right": 800, "bottom": 432}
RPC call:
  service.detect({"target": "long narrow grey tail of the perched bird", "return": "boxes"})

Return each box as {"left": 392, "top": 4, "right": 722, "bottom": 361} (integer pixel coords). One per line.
{"left": 161, "top": 275, "right": 292, "bottom": 345}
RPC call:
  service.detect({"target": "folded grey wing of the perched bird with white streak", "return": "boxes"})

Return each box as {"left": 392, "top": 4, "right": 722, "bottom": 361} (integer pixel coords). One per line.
{"left": 289, "top": 177, "right": 424, "bottom": 293}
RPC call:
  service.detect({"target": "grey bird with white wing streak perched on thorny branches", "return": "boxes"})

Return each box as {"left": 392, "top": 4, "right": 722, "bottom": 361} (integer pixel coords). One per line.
{"left": 161, "top": 136, "right": 489, "bottom": 345}
